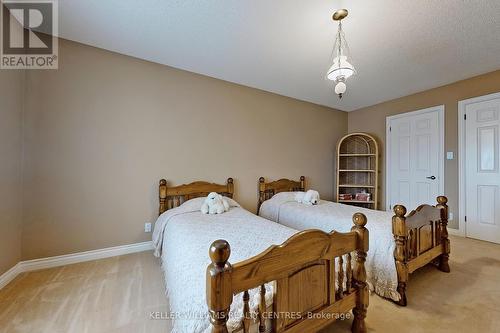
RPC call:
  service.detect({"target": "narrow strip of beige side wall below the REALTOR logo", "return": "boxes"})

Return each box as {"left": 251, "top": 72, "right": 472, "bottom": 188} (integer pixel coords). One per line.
{"left": 0, "top": 70, "right": 24, "bottom": 275}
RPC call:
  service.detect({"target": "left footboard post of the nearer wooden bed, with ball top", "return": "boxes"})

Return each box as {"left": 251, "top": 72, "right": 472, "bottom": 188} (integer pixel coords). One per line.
{"left": 206, "top": 239, "right": 233, "bottom": 333}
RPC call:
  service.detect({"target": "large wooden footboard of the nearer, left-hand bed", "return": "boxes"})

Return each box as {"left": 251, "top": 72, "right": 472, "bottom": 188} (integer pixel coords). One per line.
{"left": 206, "top": 213, "right": 368, "bottom": 333}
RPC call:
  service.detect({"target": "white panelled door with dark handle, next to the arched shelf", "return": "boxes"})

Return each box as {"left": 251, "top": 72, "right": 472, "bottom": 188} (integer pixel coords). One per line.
{"left": 386, "top": 106, "right": 444, "bottom": 212}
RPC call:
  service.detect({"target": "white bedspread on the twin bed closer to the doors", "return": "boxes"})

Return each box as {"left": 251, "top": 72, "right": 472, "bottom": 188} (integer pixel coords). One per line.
{"left": 259, "top": 192, "right": 401, "bottom": 301}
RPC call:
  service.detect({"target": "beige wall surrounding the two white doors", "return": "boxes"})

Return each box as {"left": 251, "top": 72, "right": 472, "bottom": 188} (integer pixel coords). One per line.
{"left": 348, "top": 71, "right": 500, "bottom": 228}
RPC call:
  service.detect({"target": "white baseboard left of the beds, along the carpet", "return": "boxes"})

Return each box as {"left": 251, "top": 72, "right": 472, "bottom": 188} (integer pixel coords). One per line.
{"left": 0, "top": 242, "right": 153, "bottom": 289}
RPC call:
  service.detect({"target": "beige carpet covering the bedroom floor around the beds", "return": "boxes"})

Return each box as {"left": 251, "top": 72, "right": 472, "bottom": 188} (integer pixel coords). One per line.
{"left": 0, "top": 233, "right": 500, "bottom": 333}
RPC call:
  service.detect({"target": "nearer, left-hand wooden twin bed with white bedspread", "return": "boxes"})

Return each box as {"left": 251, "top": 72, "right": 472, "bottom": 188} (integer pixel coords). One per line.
{"left": 153, "top": 179, "right": 368, "bottom": 333}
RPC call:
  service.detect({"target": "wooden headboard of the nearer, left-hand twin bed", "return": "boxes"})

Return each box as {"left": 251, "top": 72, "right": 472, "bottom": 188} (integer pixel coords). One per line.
{"left": 159, "top": 178, "right": 234, "bottom": 215}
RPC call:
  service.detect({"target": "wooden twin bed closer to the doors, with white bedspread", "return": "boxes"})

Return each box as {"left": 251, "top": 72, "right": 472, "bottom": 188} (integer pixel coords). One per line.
{"left": 258, "top": 177, "right": 450, "bottom": 306}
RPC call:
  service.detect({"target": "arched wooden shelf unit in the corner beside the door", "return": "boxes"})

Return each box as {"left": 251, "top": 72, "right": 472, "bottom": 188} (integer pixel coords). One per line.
{"left": 337, "top": 133, "right": 378, "bottom": 209}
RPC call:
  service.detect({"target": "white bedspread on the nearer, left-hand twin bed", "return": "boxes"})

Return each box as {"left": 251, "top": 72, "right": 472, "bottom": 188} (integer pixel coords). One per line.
{"left": 153, "top": 198, "right": 297, "bottom": 333}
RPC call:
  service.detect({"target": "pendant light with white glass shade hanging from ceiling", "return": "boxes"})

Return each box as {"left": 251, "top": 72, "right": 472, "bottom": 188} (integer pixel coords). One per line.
{"left": 327, "top": 9, "right": 355, "bottom": 98}
